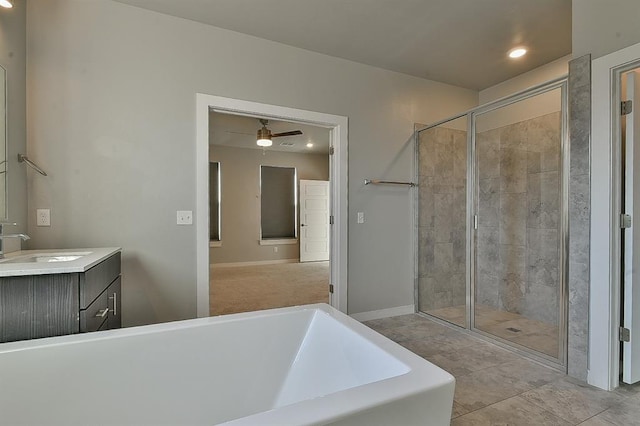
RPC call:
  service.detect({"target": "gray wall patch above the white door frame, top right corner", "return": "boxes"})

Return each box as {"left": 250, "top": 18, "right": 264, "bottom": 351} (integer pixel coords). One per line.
{"left": 571, "top": 0, "right": 640, "bottom": 59}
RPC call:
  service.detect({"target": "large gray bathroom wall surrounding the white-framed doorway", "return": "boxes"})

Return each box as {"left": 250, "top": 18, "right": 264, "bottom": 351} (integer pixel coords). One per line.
{"left": 27, "top": 0, "right": 478, "bottom": 325}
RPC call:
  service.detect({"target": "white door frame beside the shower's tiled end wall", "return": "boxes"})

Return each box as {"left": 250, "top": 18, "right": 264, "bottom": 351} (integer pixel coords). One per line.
{"left": 587, "top": 43, "right": 640, "bottom": 390}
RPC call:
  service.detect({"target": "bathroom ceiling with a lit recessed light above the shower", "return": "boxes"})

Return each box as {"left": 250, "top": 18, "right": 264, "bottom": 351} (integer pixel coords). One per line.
{"left": 115, "top": 0, "right": 571, "bottom": 90}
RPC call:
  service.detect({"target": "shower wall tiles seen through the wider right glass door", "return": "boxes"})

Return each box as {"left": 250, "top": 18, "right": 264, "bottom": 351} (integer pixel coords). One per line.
{"left": 476, "top": 112, "right": 561, "bottom": 325}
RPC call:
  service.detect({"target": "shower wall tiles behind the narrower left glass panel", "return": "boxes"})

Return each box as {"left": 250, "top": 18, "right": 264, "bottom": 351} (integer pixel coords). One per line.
{"left": 418, "top": 127, "right": 467, "bottom": 312}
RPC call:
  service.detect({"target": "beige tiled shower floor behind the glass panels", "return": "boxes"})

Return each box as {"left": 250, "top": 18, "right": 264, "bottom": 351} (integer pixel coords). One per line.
{"left": 427, "top": 304, "right": 559, "bottom": 358}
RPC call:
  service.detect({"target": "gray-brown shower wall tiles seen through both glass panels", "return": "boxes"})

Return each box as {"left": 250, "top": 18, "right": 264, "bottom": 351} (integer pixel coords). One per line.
{"left": 418, "top": 112, "right": 560, "bottom": 324}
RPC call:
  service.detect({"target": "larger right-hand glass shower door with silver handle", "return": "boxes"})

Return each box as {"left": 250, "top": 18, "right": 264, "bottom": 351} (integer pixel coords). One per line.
{"left": 472, "top": 88, "right": 564, "bottom": 359}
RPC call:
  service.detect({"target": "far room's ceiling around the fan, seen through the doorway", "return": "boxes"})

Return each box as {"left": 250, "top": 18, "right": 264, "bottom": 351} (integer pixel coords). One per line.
{"left": 209, "top": 111, "right": 330, "bottom": 155}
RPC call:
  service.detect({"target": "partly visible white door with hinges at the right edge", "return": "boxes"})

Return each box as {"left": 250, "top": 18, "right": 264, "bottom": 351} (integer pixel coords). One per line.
{"left": 622, "top": 70, "right": 640, "bottom": 384}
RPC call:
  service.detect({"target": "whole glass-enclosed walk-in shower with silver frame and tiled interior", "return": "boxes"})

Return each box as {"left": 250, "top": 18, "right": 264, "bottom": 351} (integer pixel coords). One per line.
{"left": 416, "top": 79, "right": 568, "bottom": 366}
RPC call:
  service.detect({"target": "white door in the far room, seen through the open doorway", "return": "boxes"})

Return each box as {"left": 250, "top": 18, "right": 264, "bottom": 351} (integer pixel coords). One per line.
{"left": 300, "top": 180, "right": 329, "bottom": 262}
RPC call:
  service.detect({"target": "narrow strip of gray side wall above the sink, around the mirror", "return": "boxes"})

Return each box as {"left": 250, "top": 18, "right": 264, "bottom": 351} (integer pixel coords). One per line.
{"left": 0, "top": 0, "right": 27, "bottom": 248}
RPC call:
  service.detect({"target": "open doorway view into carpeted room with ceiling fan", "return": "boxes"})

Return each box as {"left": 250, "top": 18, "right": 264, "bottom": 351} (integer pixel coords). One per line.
{"left": 209, "top": 110, "right": 330, "bottom": 315}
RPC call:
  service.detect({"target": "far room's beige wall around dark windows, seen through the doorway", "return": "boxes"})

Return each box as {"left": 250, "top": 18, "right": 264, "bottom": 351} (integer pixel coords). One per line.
{"left": 209, "top": 145, "right": 329, "bottom": 263}
